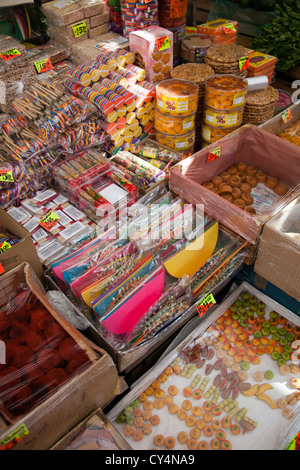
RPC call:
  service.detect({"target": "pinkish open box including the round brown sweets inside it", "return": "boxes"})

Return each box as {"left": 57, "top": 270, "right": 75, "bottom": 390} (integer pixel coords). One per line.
{"left": 170, "top": 126, "right": 299, "bottom": 243}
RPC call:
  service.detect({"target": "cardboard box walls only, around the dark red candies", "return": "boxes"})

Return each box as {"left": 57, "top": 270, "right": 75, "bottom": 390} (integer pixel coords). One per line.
{"left": 0, "top": 263, "right": 121, "bottom": 450}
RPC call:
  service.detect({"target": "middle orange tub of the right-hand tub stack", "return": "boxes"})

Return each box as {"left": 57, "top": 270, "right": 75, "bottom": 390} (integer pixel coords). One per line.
{"left": 203, "top": 106, "right": 244, "bottom": 128}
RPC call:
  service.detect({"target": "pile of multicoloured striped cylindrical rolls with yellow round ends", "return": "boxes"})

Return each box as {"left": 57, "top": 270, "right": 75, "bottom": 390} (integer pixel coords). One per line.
{"left": 65, "top": 46, "right": 156, "bottom": 153}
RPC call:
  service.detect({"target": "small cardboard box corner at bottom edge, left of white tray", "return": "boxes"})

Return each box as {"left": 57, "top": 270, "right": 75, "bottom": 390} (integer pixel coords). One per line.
{"left": 50, "top": 408, "right": 132, "bottom": 450}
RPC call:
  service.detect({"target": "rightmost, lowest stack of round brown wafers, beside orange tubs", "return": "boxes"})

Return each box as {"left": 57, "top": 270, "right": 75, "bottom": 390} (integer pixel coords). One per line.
{"left": 243, "top": 85, "right": 279, "bottom": 126}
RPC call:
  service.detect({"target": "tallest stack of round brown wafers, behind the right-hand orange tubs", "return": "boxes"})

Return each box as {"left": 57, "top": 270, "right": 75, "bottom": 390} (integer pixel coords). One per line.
{"left": 204, "top": 44, "right": 248, "bottom": 78}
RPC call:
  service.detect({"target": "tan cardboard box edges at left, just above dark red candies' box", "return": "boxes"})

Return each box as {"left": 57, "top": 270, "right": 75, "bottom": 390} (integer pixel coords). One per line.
{"left": 0, "top": 208, "right": 44, "bottom": 279}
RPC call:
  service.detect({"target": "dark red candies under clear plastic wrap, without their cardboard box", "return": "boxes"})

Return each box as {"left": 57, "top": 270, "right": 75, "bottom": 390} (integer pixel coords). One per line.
{"left": 0, "top": 272, "right": 93, "bottom": 422}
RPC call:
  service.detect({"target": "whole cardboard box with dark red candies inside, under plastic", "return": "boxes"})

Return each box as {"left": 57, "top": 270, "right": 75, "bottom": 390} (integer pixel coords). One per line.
{"left": 0, "top": 263, "right": 120, "bottom": 450}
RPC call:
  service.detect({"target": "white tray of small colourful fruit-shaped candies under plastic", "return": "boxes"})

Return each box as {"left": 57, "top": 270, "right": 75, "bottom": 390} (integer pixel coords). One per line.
{"left": 108, "top": 283, "right": 300, "bottom": 450}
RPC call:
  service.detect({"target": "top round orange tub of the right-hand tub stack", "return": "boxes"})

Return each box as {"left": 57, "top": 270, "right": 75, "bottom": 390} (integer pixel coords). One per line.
{"left": 205, "top": 74, "right": 248, "bottom": 110}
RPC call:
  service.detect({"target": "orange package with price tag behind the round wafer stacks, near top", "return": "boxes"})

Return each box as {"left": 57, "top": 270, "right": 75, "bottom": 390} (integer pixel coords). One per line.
{"left": 197, "top": 18, "right": 238, "bottom": 44}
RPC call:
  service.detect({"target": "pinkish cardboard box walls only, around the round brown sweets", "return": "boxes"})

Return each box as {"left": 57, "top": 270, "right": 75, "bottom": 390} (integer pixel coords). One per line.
{"left": 170, "top": 125, "right": 300, "bottom": 244}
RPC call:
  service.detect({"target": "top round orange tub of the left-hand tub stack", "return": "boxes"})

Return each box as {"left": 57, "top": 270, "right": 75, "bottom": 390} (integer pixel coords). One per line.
{"left": 156, "top": 79, "right": 199, "bottom": 116}
